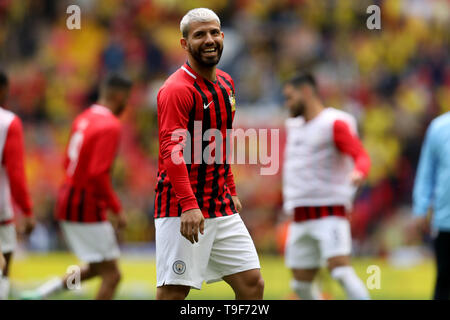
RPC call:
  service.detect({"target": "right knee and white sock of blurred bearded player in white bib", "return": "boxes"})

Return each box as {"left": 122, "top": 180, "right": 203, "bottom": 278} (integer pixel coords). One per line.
{"left": 328, "top": 256, "right": 370, "bottom": 300}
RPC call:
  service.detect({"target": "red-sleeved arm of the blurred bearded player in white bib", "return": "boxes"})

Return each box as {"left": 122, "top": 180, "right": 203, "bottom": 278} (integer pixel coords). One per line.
{"left": 333, "top": 120, "right": 370, "bottom": 180}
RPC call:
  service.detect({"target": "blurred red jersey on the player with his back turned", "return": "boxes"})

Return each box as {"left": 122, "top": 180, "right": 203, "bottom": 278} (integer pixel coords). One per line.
{"left": 56, "top": 104, "right": 121, "bottom": 223}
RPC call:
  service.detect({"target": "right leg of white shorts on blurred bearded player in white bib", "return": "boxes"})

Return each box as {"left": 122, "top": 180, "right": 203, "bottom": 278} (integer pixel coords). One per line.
{"left": 311, "top": 217, "right": 352, "bottom": 264}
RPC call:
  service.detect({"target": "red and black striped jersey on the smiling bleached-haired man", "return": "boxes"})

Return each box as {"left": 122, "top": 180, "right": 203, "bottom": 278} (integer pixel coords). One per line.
{"left": 155, "top": 64, "right": 236, "bottom": 218}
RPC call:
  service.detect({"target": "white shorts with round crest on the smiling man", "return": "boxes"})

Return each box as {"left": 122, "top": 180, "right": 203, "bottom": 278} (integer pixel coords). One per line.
{"left": 155, "top": 214, "right": 260, "bottom": 289}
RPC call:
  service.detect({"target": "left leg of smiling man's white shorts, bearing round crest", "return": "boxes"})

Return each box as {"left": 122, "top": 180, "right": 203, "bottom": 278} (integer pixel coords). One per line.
{"left": 155, "top": 217, "right": 215, "bottom": 290}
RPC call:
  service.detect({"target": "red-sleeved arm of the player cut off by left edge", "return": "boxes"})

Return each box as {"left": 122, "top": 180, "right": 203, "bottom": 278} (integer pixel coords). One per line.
{"left": 3, "top": 117, "right": 33, "bottom": 217}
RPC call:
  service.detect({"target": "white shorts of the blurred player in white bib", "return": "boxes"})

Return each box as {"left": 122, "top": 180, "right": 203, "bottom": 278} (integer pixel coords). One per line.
{"left": 285, "top": 217, "right": 352, "bottom": 269}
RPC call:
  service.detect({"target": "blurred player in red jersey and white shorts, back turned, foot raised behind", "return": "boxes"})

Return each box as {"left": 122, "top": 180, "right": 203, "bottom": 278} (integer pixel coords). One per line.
{"left": 22, "top": 75, "right": 131, "bottom": 300}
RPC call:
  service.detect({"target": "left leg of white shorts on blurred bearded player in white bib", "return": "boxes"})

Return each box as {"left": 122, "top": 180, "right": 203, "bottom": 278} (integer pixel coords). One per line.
{"left": 285, "top": 222, "right": 321, "bottom": 270}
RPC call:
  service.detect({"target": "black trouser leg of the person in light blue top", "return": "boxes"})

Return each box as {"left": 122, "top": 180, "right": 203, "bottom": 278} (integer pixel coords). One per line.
{"left": 434, "top": 231, "right": 450, "bottom": 300}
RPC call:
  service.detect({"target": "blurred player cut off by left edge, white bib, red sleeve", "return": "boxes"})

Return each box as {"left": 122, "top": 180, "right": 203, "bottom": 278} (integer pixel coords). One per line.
{"left": 0, "top": 72, "right": 35, "bottom": 300}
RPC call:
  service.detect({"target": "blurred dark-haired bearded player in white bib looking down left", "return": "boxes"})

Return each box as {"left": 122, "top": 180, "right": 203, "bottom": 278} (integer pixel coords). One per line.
{"left": 283, "top": 74, "right": 370, "bottom": 300}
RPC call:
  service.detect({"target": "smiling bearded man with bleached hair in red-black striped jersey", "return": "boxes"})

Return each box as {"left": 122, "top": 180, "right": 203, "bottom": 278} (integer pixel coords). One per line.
{"left": 155, "top": 8, "right": 264, "bottom": 299}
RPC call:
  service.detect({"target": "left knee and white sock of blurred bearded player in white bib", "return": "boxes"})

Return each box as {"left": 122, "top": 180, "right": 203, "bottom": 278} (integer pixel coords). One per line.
{"left": 291, "top": 268, "right": 321, "bottom": 300}
